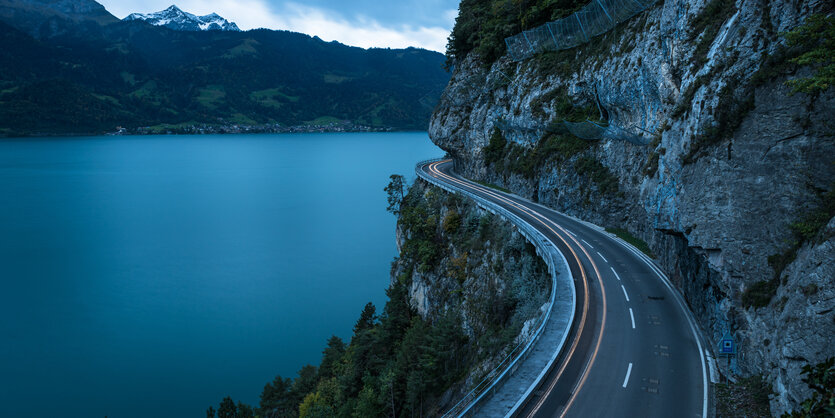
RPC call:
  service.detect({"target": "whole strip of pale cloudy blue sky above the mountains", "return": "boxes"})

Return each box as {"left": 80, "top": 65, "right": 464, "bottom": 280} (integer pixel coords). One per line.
{"left": 99, "top": 0, "right": 459, "bottom": 52}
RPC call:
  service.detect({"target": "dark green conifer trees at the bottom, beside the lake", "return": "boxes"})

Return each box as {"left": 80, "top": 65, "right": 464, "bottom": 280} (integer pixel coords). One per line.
{"left": 209, "top": 276, "right": 469, "bottom": 417}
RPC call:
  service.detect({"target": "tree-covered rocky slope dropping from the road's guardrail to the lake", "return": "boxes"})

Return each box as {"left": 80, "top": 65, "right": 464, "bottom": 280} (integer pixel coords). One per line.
{"left": 207, "top": 179, "right": 548, "bottom": 417}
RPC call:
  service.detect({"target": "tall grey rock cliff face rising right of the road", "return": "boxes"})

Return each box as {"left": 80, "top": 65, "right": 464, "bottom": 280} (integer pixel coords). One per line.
{"left": 430, "top": 0, "right": 835, "bottom": 414}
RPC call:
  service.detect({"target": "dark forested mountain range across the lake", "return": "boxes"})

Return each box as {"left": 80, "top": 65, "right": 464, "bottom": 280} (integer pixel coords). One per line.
{"left": 0, "top": 0, "right": 449, "bottom": 136}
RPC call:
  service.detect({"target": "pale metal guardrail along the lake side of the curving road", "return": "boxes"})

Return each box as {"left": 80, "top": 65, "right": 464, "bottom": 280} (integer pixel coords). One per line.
{"left": 415, "top": 158, "right": 576, "bottom": 417}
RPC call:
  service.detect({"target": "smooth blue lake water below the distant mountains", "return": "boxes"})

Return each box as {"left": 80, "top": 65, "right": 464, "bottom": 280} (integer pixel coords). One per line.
{"left": 0, "top": 133, "right": 441, "bottom": 417}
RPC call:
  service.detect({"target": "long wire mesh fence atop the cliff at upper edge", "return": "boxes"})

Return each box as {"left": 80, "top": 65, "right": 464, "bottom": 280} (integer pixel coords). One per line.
{"left": 505, "top": 0, "right": 658, "bottom": 61}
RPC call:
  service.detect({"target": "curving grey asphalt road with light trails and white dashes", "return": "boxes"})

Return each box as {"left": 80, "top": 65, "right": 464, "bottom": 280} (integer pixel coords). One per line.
{"left": 418, "top": 160, "right": 710, "bottom": 417}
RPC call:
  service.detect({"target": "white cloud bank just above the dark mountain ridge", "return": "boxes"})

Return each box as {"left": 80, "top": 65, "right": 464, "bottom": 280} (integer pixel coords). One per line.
{"left": 104, "top": 0, "right": 457, "bottom": 52}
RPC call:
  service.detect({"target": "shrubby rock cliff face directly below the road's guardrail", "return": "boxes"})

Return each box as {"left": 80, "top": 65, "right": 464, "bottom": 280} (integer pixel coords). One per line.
{"left": 392, "top": 180, "right": 551, "bottom": 412}
